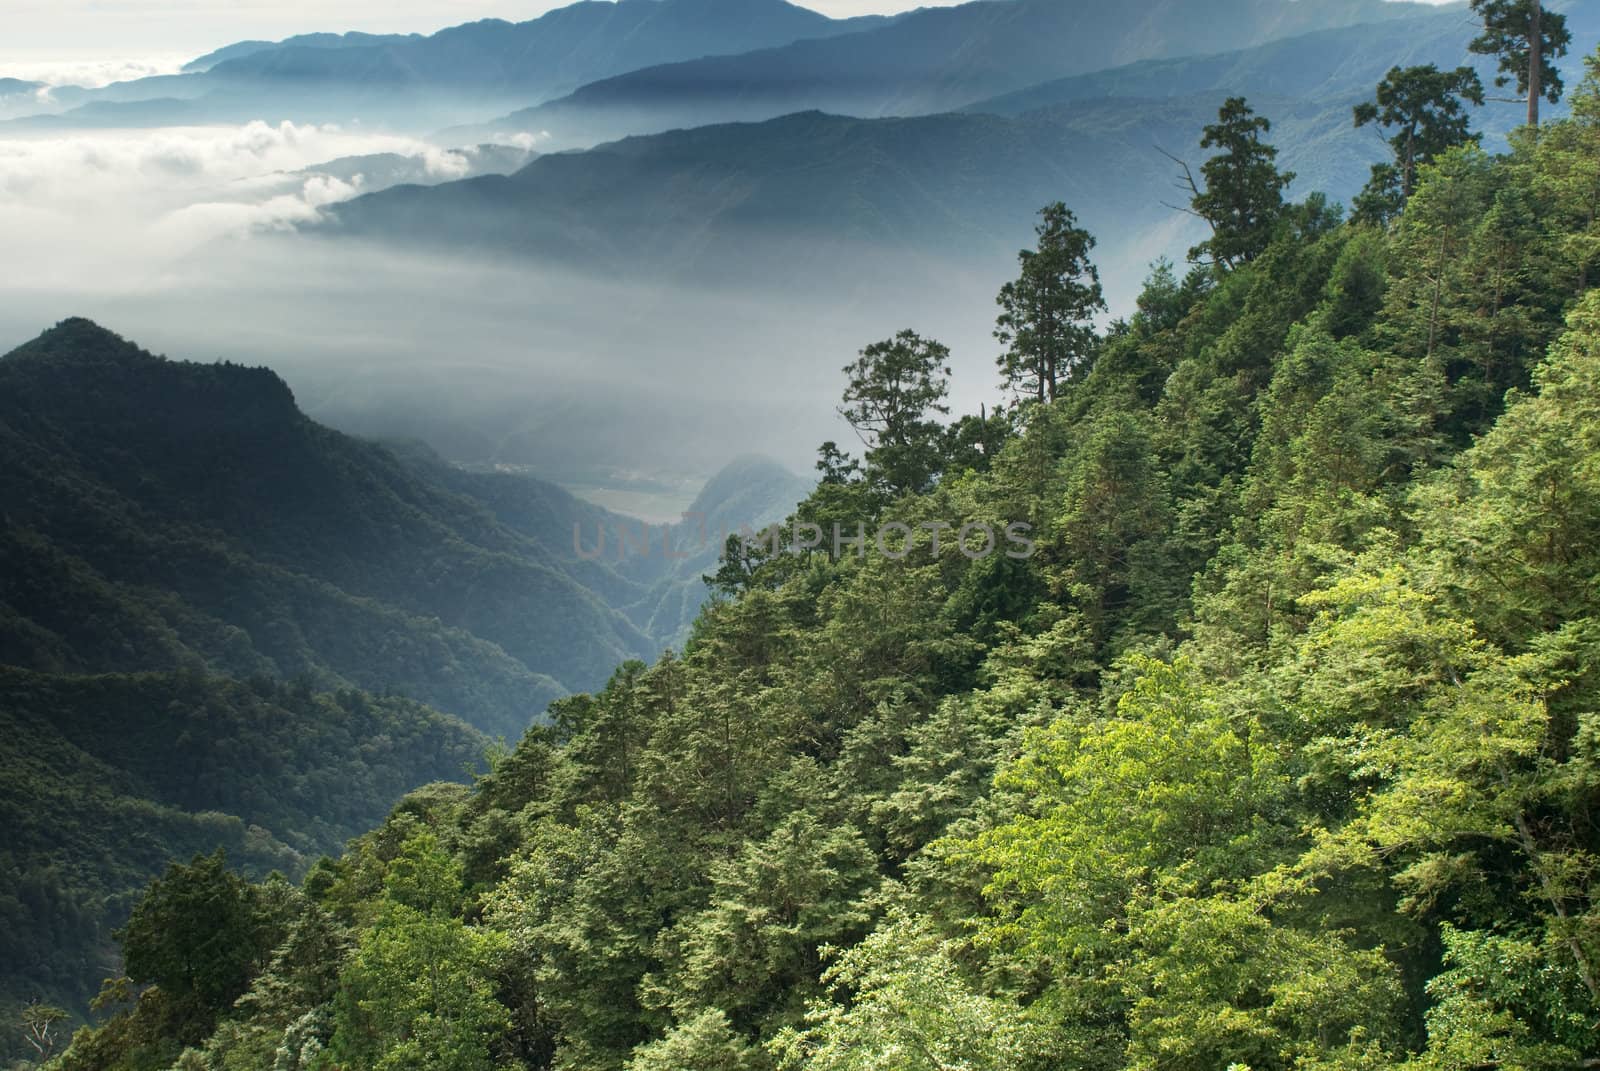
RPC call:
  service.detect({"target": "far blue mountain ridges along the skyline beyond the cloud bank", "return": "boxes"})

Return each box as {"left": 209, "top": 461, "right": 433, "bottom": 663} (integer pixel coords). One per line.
{"left": 3, "top": 0, "right": 1465, "bottom": 136}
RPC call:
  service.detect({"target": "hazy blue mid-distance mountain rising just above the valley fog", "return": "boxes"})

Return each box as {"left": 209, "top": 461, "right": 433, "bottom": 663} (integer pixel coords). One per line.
{"left": 317, "top": 96, "right": 1350, "bottom": 301}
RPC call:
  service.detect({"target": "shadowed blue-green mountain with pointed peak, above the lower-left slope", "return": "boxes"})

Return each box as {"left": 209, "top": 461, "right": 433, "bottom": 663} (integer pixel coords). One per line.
{"left": 0, "top": 320, "right": 796, "bottom": 733}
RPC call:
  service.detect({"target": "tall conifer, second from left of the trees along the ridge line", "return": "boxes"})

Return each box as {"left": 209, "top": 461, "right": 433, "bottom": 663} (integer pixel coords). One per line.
{"left": 995, "top": 202, "right": 1106, "bottom": 402}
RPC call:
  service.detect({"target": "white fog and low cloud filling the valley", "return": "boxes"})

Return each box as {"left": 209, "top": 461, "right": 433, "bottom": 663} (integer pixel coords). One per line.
{"left": 0, "top": 122, "right": 1088, "bottom": 493}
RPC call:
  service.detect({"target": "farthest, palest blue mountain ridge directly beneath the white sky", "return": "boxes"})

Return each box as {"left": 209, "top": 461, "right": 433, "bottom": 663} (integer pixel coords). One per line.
{"left": 18, "top": 0, "right": 886, "bottom": 130}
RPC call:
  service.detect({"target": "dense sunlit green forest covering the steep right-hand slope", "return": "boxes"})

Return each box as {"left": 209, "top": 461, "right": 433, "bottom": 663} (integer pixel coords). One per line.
{"left": 19, "top": 12, "right": 1600, "bottom": 1071}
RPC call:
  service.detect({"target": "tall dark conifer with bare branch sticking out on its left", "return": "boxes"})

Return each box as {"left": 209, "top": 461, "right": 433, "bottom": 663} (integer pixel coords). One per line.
{"left": 1184, "top": 96, "right": 1294, "bottom": 269}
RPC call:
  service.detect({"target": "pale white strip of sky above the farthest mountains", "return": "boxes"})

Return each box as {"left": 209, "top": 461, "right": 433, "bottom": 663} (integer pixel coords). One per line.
{"left": 0, "top": 0, "right": 958, "bottom": 64}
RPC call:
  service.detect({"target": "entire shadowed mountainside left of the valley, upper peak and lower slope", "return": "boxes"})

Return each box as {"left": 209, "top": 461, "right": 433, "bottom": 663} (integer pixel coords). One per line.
{"left": 0, "top": 320, "right": 808, "bottom": 1058}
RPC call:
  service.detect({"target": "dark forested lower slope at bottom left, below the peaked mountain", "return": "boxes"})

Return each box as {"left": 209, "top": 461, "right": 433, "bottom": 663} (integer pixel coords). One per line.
{"left": 0, "top": 666, "right": 488, "bottom": 1024}
